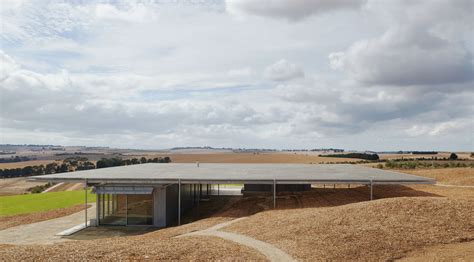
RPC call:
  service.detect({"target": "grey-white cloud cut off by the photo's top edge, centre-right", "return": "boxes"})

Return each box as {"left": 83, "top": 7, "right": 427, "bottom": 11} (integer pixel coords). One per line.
{"left": 226, "top": 0, "right": 366, "bottom": 20}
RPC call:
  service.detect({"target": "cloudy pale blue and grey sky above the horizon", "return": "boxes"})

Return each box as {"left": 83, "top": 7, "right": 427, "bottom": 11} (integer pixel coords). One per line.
{"left": 0, "top": 0, "right": 474, "bottom": 151}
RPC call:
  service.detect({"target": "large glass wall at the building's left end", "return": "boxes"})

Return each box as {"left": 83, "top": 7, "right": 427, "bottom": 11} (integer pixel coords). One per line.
{"left": 98, "top": 194, "right": 153, "bottom": 226}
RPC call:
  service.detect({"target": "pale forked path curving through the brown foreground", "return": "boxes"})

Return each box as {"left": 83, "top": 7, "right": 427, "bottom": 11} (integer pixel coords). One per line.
{"left": 178, "top": 217, "right": 295, "bottom": 261}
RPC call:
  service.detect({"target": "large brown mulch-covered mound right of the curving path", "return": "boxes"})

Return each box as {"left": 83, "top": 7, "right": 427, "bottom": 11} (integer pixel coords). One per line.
{"left": 224, "top": 197, "right": 474, "bottom": 260}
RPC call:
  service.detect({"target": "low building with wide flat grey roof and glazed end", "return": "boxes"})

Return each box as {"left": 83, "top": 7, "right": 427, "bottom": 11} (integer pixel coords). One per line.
{"left": 32, "top": 163, "right": 435, "bottom": 227}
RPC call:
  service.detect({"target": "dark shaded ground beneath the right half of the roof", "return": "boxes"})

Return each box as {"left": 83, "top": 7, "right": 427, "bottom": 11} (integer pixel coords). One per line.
{"left": 190, "top": 185, "right": 442, "bottom": 222}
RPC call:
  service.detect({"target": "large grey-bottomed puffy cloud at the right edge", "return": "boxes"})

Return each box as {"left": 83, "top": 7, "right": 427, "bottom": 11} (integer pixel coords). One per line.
{"left": 329, "top": 30, "right": 474, "bottom": 85}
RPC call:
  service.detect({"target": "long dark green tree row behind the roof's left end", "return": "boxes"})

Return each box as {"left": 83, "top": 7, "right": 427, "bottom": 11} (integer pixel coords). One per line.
{"left": 0, "top": 157, "right": 171, "bottom": 178}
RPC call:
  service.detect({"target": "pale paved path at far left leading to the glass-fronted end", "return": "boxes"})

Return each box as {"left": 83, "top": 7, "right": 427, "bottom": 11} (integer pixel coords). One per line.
{"left": 0, "top": 204, "right": 96, "bottom": 245}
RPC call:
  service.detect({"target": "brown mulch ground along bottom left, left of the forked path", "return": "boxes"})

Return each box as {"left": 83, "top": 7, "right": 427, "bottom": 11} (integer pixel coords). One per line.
{"left": 0, "top": 218, "right": 266, "bottom": 261}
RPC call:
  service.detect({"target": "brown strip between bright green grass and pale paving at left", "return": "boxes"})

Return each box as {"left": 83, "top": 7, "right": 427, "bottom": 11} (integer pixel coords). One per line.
{"left": 0, "top": 204, "right": 88, "bottom": 230}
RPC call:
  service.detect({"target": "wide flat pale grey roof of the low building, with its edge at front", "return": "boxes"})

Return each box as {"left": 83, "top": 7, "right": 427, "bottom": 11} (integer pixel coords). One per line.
{"left": 32, "top": 163, "right": 435, "bottom": 184}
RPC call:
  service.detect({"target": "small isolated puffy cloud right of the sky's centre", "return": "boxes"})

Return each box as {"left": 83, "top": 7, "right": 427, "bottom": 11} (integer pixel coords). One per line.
{"left": 263, "top": 59, "right": 304, "bottom": 81}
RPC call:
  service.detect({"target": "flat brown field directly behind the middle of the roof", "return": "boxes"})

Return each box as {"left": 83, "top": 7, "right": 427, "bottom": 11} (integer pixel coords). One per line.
{"left": 152, "top": 152, "right": 360, "bottom": 164}
